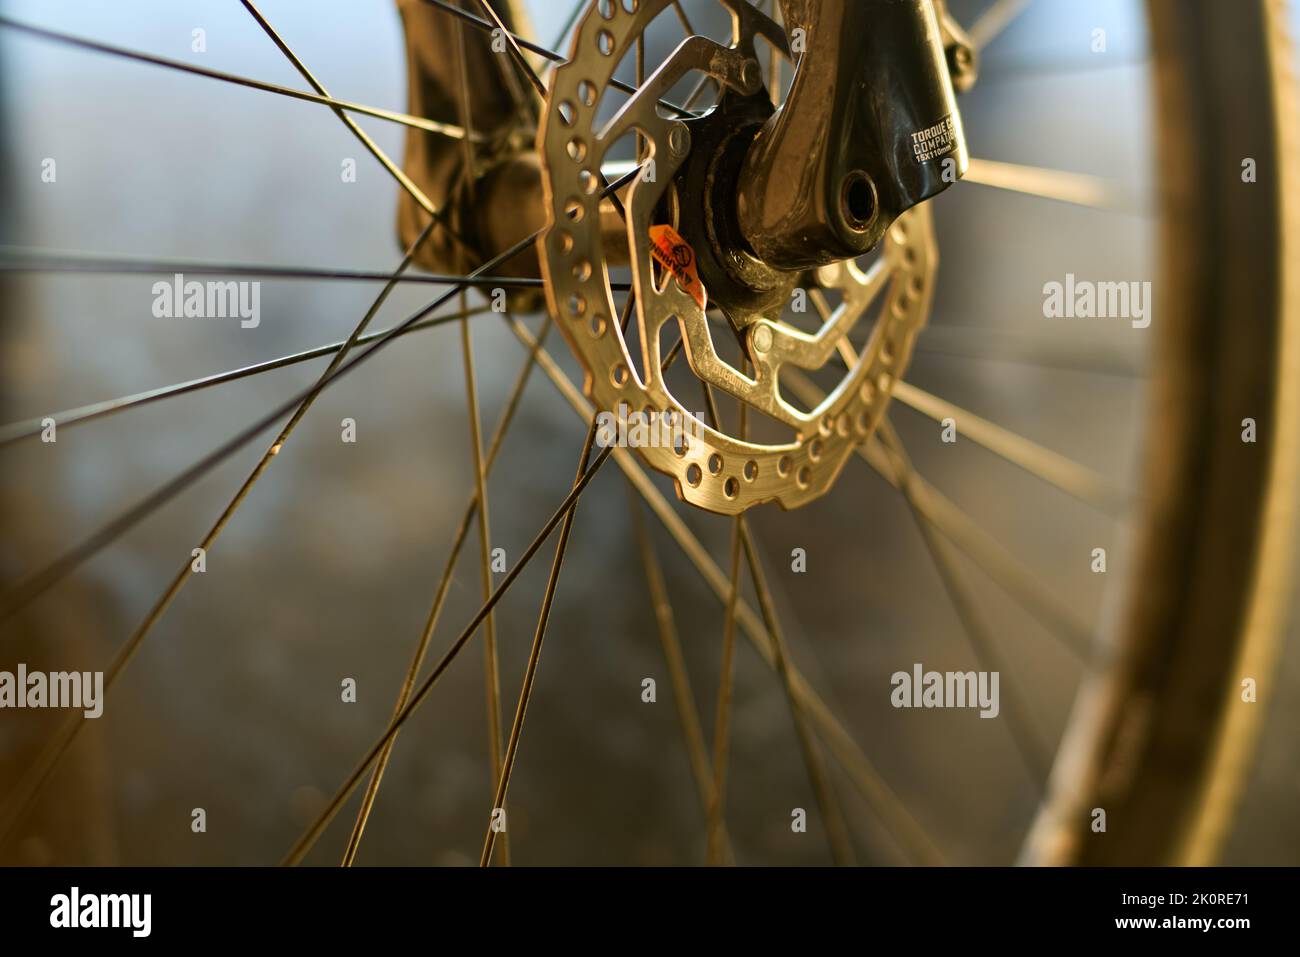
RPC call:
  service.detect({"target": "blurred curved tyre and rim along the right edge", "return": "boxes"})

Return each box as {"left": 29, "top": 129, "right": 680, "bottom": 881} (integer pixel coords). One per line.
{"left": 1031, "top": 1, "right": 1300, "bottom": 865}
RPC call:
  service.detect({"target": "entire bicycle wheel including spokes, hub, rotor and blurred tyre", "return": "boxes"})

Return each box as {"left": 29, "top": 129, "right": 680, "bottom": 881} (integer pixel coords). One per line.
{"left": 0, "top": 0, "right": 1300, "bottom": 863}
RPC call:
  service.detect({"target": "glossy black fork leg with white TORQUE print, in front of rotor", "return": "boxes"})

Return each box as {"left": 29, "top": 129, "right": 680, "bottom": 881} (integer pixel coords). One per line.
{"left": 737, "top": 0, "right": 975, "bottom": 270}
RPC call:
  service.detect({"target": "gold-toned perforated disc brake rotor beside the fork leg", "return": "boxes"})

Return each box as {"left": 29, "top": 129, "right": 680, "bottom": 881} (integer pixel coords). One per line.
{"left": 538, "top": 0, "right": 937, "bottom": 515}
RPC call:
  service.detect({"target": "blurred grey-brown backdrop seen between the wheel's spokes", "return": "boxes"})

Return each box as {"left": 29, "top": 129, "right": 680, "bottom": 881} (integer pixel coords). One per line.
{"left": 0, "top": 0, "right": 1300, "bottom": 865}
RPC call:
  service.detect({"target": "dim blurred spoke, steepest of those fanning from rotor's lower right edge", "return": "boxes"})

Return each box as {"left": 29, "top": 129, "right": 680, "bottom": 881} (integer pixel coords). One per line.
{"left": 880, "top": 416, "right": 1050, "bottom": 797}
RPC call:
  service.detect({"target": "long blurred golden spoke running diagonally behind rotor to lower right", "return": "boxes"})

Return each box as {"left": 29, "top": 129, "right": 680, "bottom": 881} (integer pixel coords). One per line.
{"left": 510, "top": 320, "right": 944, "bottom": 863}
